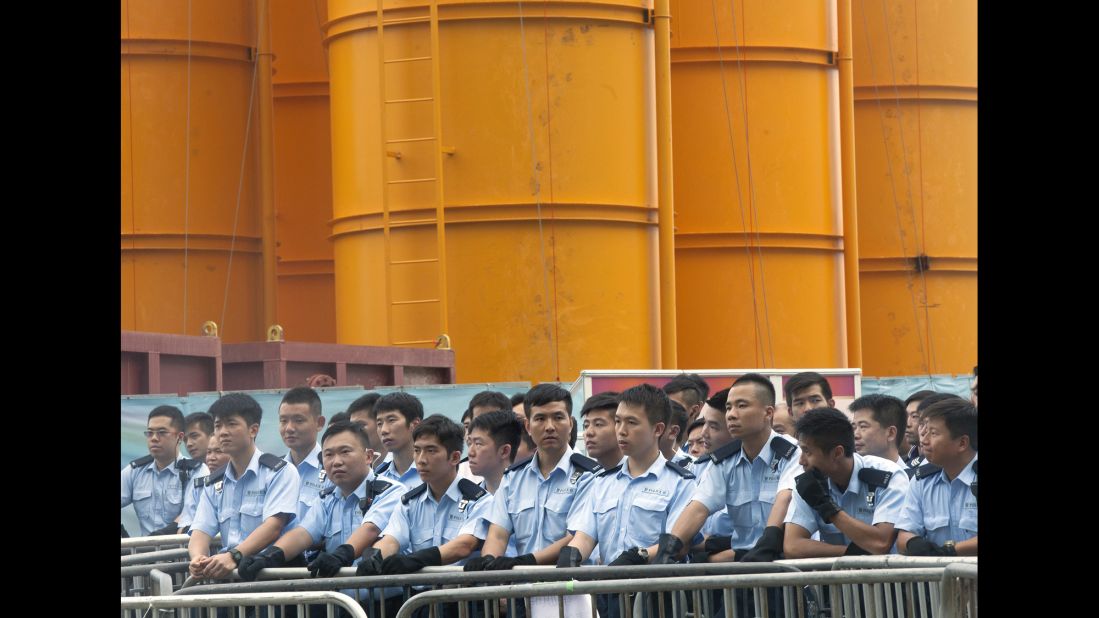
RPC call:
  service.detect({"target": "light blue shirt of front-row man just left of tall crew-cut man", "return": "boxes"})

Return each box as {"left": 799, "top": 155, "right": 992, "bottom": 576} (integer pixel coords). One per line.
{"left": 568, "top": 453, "right": 695, "bottom": 564}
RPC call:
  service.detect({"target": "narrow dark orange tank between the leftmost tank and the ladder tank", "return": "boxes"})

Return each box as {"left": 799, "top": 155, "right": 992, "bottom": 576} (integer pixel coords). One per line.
{"left": 270, "top": 0, "right": 336, "bottom": 343}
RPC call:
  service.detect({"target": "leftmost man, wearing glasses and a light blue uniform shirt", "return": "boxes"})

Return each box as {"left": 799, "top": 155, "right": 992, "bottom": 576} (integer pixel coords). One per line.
{"left": 121, "top": 406, "right": 208, "bottom": 537}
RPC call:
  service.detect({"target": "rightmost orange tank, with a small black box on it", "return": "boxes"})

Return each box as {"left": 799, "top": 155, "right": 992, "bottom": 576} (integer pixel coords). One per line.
{"left": 852, "top": 0, "right": 977, "bottom": 376}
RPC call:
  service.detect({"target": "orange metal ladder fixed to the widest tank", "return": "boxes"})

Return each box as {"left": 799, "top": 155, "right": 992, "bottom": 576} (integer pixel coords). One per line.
{"left": 377, "top": 0, "right": 454, "bottom": 347}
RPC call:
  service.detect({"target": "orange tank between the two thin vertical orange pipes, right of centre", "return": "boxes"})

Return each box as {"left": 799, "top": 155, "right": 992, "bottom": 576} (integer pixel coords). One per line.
{"left": 671, "top": 0, "right": 847, "bottom": 367}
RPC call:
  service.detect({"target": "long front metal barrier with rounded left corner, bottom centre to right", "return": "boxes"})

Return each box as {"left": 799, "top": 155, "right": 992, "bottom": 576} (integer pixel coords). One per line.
{"left": 397, "top": 567, "right": 953, "bottom": 618}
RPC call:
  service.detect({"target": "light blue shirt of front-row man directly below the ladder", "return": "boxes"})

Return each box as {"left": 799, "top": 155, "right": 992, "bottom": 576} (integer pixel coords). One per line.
{"left": 381, "top": 475, "right": 492, "bottom": 564}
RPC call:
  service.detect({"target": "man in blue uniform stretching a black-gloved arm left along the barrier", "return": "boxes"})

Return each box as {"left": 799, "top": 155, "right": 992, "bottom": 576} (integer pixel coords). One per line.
{"left": 237, "top": 421, "right": 408, "bottom": 582}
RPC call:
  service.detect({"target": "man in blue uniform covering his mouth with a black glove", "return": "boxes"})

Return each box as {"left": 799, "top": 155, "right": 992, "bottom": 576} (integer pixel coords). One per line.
{"left": 785, "top": 400, "right": 908, "bottom": 559}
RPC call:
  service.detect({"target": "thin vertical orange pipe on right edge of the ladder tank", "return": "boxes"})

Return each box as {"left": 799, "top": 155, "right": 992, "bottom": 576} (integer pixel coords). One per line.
{"left": 653, "top": 0, "right": 678, "bottom": 369}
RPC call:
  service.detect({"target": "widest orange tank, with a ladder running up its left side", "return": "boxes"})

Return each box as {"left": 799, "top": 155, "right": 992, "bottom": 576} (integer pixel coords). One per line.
{"left": 326, "top": 0, "right": 659, "bottom": 382}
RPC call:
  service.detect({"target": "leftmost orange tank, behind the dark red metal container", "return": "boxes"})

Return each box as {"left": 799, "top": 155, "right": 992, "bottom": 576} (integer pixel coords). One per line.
{"left": 121, "top": 0, "right": 264, "bottom": 342}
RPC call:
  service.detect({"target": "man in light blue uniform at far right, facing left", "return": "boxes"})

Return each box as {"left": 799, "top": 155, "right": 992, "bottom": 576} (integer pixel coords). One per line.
{"left": 897, "top": 397, "right": 977, "bottom": 555}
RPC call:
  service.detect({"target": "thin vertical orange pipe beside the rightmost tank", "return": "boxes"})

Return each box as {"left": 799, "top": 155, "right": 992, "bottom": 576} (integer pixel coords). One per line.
{"left": 836, "top": 0, "right": 863, "bottom": 367}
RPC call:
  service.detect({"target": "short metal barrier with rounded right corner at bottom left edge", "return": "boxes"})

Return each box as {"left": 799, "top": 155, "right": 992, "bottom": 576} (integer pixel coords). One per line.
{"left": 122, "top": 593, "right": 367, "bottom": 618}
